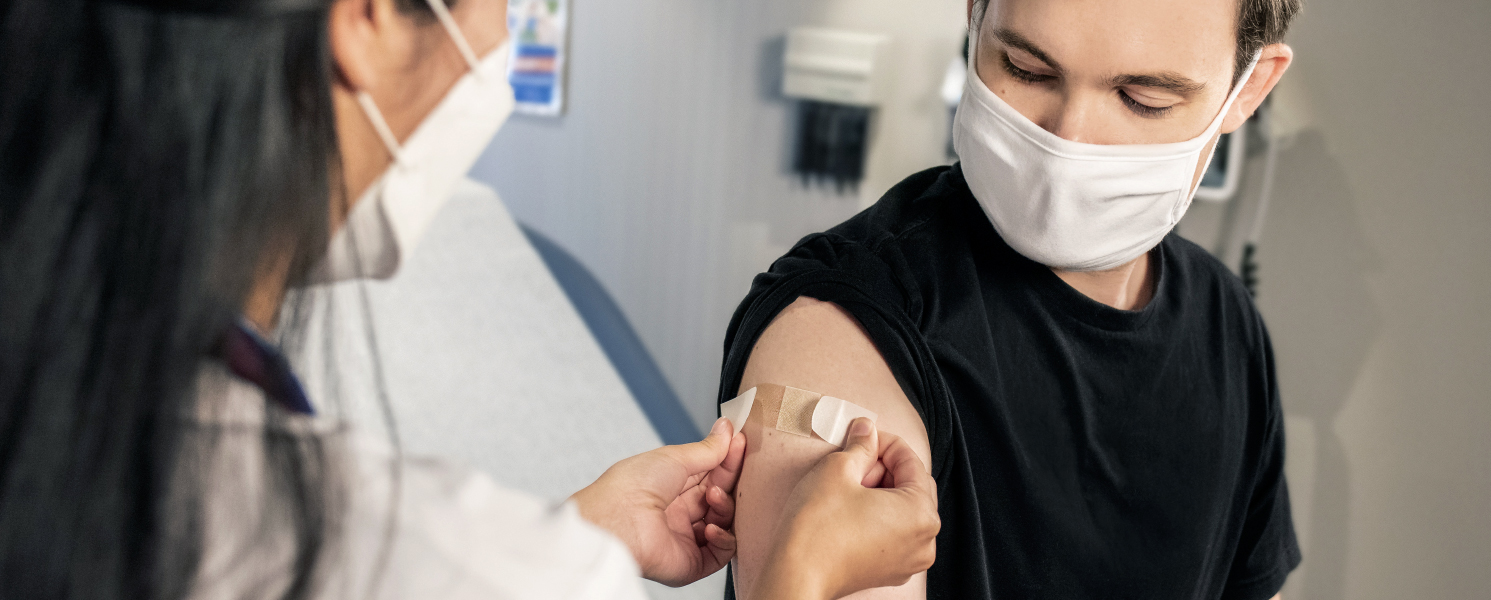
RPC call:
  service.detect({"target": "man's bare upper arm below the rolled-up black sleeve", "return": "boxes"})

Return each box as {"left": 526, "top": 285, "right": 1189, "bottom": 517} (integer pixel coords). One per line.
{"left": 735, "top": 297, "right": 932, "bottom": 599}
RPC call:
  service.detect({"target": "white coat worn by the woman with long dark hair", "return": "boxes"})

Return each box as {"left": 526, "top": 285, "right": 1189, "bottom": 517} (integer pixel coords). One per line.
{"left": 183, "top": 364, "right": 646, "bottom": 600}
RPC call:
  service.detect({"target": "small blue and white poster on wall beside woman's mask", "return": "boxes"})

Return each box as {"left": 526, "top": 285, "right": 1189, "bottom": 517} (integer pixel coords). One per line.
{"left": 507, "top": 0, "right": 570, "bottom": 116}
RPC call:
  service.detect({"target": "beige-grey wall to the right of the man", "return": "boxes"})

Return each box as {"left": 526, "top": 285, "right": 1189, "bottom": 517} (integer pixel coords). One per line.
{"left": 1182, "top": 0, "right": 1491, "bottom": 600}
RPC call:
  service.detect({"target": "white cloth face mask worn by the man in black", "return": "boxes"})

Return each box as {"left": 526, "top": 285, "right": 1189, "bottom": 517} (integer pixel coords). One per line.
{"left": 953, "top": 34, "right": 1258, "bottom": 270}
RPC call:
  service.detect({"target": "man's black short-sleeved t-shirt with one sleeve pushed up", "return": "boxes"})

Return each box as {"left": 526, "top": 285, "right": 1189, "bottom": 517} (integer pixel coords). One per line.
{"left": 720, "top": 166, "right": 1300, "bottom": 600}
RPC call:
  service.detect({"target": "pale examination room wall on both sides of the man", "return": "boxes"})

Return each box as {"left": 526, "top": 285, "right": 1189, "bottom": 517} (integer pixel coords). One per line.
{"left": 474, "top": 0, "right": 1491, "bottom": 600}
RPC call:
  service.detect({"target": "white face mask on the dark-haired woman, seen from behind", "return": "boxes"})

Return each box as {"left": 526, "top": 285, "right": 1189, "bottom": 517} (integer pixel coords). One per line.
{"left": 315, "top": 0, "right": 514, "bottom": 282}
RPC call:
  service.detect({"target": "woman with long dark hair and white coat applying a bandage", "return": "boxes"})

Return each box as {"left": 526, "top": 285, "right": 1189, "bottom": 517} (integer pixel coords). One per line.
{"left": 0, "top": 0, "right": 938, "bottom": 599}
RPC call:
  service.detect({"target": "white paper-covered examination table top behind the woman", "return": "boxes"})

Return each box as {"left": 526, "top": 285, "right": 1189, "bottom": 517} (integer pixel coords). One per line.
{"left": 308, "top": 181, "right": 664, "bottom": 501}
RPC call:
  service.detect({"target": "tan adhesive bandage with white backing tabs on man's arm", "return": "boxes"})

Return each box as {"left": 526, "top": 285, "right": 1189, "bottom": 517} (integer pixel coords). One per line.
{"left": 720, "top": 384, "right": 875, "bottom": 448}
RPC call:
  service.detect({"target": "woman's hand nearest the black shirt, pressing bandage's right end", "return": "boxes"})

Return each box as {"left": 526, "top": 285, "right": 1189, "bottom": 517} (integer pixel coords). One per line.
{"left": 751, "top": 418, "right": 942, "bottom": 599}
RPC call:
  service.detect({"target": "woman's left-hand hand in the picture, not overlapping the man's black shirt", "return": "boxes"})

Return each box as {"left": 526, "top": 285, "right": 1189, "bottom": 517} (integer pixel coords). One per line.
{"left": 570, "top": 419, "right": 746, "bottom": 587}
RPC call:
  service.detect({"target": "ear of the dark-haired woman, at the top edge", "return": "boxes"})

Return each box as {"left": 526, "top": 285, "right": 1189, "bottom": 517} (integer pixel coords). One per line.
{"left": 327, "top": 0, "right": 395, "bottom": 91}
